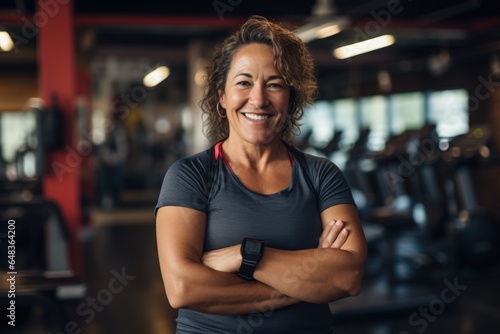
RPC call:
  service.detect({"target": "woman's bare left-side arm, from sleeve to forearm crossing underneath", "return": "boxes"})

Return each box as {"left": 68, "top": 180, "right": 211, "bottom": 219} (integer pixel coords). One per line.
{"left": 156, "top": 206, "right": 298, "bottom": 314}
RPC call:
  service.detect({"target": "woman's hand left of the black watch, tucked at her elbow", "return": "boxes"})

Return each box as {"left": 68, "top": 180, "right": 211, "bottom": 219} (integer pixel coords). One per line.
{"left": 201, "top": 244, "right": 241, "bottom": 273}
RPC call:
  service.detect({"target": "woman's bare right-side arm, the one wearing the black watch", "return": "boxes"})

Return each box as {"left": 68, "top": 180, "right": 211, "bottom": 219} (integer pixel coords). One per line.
{"left": 203, "top": 204, "right": 367, "bottom": 303}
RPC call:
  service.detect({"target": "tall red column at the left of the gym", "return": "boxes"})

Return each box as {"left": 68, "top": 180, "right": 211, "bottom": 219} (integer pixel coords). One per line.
{"left": 37, "top": 0, "right": 82, "bottom": 274}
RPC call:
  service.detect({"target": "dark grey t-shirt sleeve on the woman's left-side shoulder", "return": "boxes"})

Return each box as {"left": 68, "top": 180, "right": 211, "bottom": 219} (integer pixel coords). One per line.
{"left": 155, "top": 151, "right": 210, "bottom": 216}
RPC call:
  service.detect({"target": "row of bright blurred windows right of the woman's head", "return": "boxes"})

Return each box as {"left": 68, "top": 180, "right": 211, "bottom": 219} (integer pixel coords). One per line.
{"left": 298, "top": 89, "right": 469, "bottom": 168}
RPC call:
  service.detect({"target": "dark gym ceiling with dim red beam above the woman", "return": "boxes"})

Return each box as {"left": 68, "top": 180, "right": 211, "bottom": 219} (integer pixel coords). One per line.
{"left": 0, "top": 0, "right": 500, "bottom": 96}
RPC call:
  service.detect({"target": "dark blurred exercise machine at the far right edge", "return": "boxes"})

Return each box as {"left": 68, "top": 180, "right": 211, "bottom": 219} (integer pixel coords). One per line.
{"left": 443, "top": 126, "right": 500, "bottom": 271}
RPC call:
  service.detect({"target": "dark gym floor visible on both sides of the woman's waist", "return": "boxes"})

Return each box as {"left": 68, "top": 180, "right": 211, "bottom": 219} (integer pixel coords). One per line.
{"left": 8, "top": 189, "right": 500, "bottom": 334}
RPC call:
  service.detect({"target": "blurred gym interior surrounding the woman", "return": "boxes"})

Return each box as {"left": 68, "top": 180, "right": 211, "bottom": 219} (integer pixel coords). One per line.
{"left": 0, "top": 0, "right": 500, "bottom": 334}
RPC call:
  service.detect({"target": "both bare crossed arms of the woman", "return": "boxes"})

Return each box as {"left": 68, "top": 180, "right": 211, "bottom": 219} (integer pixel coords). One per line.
{"left": 156, "top": 204, "right": 366, "bottom": 314}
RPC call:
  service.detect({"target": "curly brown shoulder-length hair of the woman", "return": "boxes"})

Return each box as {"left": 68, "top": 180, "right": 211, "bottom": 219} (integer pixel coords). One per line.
{"left": 200, "top": 15, "right": 317, "bottom": 145}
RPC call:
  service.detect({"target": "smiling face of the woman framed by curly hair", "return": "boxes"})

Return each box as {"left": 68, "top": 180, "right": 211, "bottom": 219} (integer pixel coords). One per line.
{"left": 220, "top": 44, "right": 290, "bottom": 145}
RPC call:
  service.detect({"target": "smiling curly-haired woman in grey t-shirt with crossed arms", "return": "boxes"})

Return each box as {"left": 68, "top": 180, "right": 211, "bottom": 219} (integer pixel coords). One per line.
{"left": 156, "top": 16, "right": 366, "bottom": 334}
